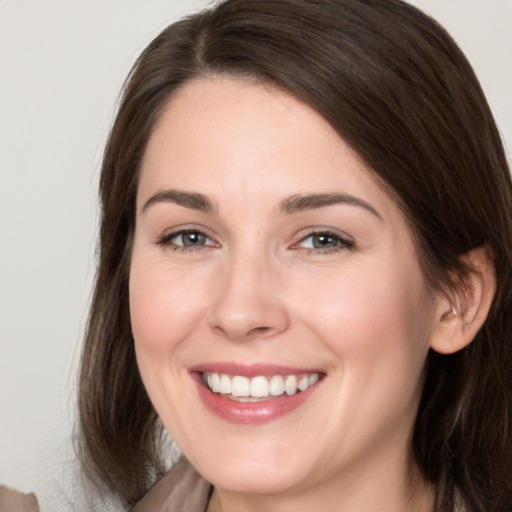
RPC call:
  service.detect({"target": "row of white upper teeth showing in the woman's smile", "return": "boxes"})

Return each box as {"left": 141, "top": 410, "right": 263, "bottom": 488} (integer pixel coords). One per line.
{"left": 203, "top": 372, "right": 320, "bottom": 398}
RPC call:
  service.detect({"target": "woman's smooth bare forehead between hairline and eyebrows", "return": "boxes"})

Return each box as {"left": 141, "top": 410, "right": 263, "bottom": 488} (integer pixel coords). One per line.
{"left": 138, "top": 77, "right": 400, "bottom": 222}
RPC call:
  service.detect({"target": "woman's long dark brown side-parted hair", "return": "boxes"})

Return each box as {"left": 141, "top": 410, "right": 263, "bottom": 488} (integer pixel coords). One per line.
{"left": 79, "top": 0, "right": 512, "bottom": 512}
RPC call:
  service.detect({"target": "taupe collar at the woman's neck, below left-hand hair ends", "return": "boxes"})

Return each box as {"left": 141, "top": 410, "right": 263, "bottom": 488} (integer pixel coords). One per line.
{"left": 131, "top": 457, "right": 212, "bottom": 512}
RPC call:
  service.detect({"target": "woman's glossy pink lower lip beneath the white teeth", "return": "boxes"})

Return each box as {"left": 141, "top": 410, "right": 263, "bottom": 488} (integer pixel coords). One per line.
{"left": 194, "top": 378, "right": 318, "bottom": 425}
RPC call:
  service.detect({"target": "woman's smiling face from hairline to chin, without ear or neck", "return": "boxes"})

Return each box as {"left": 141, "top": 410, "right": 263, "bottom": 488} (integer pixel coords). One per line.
{"left": 130, "top": 78, "right": 437, "bottom": 493}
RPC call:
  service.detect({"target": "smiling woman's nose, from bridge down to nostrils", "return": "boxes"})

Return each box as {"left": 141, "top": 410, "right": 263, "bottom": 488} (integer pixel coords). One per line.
{"left": 208, "top": 250, "right": 289, "bottom": 341}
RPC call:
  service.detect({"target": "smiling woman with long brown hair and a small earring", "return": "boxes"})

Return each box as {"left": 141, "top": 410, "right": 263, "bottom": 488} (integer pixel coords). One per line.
{"left": 80, "top": 0, "right": 512, "bottom": 512}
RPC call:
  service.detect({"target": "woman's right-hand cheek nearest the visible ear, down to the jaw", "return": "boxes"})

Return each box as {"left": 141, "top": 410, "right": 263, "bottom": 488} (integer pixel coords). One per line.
{"left": 294, "top": 265, "right": 433, "bottom": 450}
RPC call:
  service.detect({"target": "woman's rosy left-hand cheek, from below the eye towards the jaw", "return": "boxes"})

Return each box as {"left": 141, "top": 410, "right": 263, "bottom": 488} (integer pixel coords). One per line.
{"left": 129, "top": 252, "right": 208, "bottom": 432}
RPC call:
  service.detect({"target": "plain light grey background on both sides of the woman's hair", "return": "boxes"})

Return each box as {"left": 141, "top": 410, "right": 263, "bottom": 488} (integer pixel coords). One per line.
{"left": 0, "top": 0, "right": 512, "bottom": 504}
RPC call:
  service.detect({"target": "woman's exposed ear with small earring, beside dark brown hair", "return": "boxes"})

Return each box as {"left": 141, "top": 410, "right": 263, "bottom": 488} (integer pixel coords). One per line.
{"left": 430, "top": 245, "right": 496, "bottom": 354}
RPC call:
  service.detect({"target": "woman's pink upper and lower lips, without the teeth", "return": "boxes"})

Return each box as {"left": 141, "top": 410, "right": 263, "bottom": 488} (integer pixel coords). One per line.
{"left": 189, "top": 363, "right": 320, "bottom": 425}
